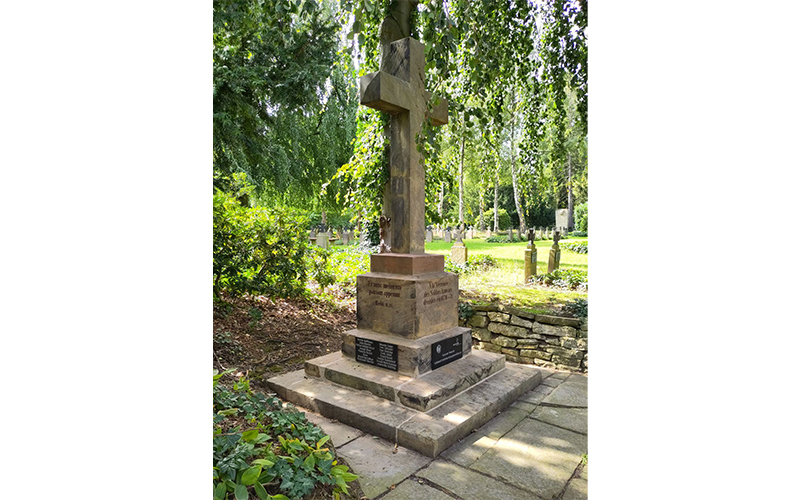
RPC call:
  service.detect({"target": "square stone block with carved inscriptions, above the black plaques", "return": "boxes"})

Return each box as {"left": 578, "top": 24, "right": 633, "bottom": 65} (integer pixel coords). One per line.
{"left": 356, "top": 274, "right": 458, "bottom": 339}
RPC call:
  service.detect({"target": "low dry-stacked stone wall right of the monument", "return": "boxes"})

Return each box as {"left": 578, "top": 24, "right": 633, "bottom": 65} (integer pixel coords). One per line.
{"left": 462, "top": 304, "right": 589, "bottom": 372}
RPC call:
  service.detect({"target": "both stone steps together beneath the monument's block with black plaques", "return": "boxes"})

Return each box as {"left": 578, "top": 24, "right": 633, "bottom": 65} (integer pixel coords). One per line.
{"left": 267, "top": 360, "right": 542, "bottom": 458}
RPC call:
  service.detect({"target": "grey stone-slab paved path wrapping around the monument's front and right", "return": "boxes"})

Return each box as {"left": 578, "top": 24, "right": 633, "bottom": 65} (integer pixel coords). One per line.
{"left": 307, "top": 369, "right": 588, "bottom": 500}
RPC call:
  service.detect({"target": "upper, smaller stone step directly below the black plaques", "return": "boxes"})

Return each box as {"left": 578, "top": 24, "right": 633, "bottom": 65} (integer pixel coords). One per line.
{"left": 305, "top": 351, "right": 505, "bottom": 411}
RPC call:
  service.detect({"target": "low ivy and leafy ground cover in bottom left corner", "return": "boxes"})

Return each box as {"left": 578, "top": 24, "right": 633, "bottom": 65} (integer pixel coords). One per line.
{"left": 213, "top": 370, "right": 357, "bottom": 500}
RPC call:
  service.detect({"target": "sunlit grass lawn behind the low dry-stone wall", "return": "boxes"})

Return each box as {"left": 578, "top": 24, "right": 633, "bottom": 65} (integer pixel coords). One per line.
{"left": 425, "top": 237, "right": 589, "bottom": 312}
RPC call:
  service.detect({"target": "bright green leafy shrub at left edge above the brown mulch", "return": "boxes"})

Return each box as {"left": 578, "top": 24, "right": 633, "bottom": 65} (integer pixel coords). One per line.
{"left": 213, "top": 174, "right": 308, "bottom": 298}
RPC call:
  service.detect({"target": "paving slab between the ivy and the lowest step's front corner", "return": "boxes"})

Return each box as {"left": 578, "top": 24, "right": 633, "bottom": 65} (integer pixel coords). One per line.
{"left": 336, "top": 435, "right": 431, "bottom": 498}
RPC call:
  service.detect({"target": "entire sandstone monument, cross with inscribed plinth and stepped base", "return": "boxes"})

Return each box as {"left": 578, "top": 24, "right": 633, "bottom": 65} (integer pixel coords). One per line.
{"left": 268, "top": 1, "right": 541, "bottom": 457}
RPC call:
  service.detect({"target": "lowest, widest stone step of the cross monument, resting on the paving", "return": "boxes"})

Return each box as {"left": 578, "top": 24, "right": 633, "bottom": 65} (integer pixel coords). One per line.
{"left": 267, "top": 363, "right": 542, "bottom": 458}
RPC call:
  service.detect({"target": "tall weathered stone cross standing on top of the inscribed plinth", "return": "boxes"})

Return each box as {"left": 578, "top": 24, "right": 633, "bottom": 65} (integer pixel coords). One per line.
{"left": 359, "top": 34, "right": 447, "bottom": 254}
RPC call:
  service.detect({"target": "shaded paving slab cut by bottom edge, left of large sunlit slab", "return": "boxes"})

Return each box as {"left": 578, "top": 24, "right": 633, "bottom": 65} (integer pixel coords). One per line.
{"left": 417, "top": 459, "right": 539, "bottom": 500}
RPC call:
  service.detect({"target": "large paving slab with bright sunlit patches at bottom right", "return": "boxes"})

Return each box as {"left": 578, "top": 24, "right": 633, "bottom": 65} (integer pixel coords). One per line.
{"left": 470, "top": 418, "right": 588, "bottom": 499}
